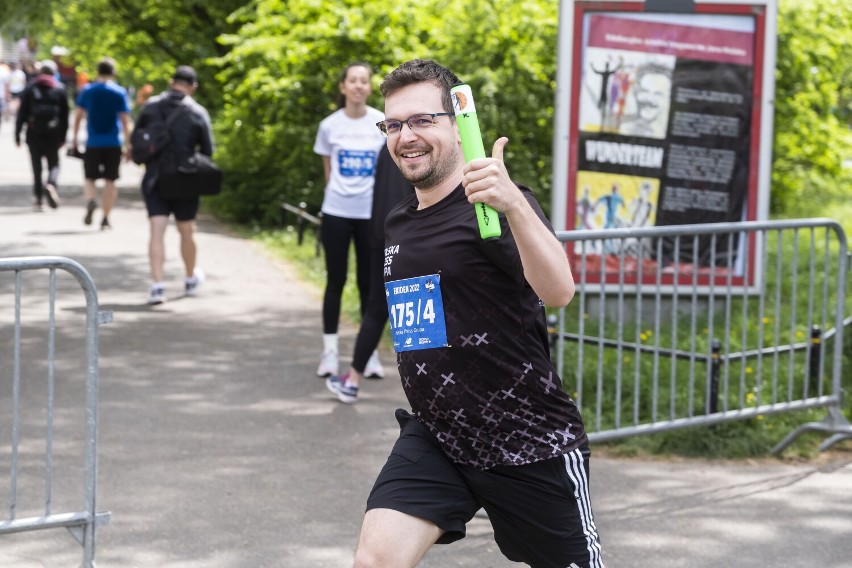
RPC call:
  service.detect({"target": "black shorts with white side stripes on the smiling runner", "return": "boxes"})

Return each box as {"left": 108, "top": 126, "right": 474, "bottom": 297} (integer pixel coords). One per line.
{"left": 367, "top": 410, "right": 603, "bottom": 568}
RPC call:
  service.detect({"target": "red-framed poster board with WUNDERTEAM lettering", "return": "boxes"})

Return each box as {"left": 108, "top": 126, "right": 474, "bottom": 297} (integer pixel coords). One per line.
{"left": 552, "top": 0, "right": 777, "bottom": 289}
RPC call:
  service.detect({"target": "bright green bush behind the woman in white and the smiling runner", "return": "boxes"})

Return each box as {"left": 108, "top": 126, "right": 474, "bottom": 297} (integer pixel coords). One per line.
{"left": 212, "top": 0, "right": 557, "bottom": 224}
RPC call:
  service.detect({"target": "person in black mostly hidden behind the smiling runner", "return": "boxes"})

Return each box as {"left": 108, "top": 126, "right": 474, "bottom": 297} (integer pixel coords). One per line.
{"left": 326, "top": 144, "right": 414, "bottom": 404}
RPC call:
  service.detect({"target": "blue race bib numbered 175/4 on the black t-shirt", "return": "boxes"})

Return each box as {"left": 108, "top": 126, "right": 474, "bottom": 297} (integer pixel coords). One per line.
{"left": 385, "top": 274, "right": 448, "bottom": 353}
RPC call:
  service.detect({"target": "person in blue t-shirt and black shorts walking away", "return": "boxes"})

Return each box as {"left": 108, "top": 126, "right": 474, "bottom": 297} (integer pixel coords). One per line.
{"left": 71, "top": 57, "right": 130, "bottom": 230}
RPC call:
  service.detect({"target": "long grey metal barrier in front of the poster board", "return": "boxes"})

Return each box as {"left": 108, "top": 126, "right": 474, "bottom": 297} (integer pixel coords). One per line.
{"left": 555, "top": 219, "right": 852, "bottom": 453}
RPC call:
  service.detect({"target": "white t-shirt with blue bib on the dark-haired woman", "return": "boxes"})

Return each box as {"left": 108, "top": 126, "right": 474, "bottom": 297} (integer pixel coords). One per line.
{"left": 314, "top": 106, "right": 385, "bottom": 219}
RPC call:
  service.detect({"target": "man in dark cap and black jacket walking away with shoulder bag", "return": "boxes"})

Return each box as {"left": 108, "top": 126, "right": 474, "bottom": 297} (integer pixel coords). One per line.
{"left": 128, "top": 65, "right": 214, "bottom": 305}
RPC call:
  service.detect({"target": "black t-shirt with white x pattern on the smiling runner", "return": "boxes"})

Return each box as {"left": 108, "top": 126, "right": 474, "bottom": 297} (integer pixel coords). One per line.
{"left": 385, "top": 185, "right": 586, "bottom": 469}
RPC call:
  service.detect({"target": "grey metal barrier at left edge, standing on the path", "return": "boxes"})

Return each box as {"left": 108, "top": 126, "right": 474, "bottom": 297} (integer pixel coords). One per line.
{"left": 0, "top": 257, "right": 112, "bottom": 568}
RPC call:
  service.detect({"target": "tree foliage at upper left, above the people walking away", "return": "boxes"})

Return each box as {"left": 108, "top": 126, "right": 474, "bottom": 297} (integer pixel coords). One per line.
{"left": 0, "top": 0, "right": 250, "bottom": 108}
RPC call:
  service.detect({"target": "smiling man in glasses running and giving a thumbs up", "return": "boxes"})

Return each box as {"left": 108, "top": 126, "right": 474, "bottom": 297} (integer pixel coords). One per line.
{"left": 348, "top": 60, "right": 603, "bottom": 568}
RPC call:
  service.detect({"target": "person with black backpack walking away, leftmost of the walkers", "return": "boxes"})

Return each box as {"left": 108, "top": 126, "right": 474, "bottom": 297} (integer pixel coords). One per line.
{"left": 15, "top": 60, "right": 68, "bottom": 211}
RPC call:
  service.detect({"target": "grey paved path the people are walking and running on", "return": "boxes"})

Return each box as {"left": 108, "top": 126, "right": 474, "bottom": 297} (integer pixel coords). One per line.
{"left": 0, "top": 123, "right": 852, "bottom": 568}
